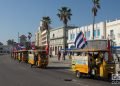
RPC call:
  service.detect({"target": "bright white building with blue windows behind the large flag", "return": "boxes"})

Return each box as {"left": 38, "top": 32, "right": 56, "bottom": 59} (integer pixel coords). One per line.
{"left": 67, "top": 22, "right": 106, "bottom": 48}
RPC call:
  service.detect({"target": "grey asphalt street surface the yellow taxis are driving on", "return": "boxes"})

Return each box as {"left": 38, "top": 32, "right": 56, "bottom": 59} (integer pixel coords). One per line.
{"left": 0, "top": 55, "right": 114, "bottom": 86}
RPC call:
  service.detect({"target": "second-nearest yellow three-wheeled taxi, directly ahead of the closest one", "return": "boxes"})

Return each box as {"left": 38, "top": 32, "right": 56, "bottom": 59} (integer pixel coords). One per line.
{"left": 28, "top": 50, "right": 48, "bottom": 68}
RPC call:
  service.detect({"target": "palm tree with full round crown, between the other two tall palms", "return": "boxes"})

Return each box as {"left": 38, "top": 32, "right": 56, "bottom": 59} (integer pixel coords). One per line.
{"left": 57, "top": 7, "right": 72, "bottom": 53}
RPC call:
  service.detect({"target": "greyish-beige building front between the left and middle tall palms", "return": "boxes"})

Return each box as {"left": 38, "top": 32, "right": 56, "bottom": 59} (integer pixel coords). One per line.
{"left": 50, "top": 28, "right": 64, "bottom": 55}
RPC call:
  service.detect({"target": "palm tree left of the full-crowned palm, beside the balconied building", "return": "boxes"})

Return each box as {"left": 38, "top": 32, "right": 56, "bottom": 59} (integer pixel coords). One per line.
{"left": 42, "top": 16, "right": 51, "bottom": 54}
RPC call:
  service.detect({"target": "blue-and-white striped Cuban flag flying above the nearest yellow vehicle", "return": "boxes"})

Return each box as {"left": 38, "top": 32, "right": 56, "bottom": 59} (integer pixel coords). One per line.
{"left": 74, "top": 31, "right": 87, "bottom": 49}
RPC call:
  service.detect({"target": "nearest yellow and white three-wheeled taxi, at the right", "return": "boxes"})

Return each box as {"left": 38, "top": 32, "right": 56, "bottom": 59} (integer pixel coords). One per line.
{"left": 72, "top": 49, "right": 109, "bottom": 78}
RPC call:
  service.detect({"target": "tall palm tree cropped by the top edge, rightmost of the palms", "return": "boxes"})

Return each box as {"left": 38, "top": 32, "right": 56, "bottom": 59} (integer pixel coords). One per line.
{"left": 92, "top": 0, "right": 100, "bottom": 40}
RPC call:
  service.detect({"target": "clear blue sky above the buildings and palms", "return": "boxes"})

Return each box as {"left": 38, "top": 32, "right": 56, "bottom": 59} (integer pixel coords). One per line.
{"left": 0, "top": 0, "right": 120, "bottom": 44}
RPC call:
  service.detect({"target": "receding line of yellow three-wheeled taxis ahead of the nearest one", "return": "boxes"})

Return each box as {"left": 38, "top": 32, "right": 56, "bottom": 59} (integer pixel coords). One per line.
{"left": 11, "top": 50, "right": 48, "bottom": 68}
